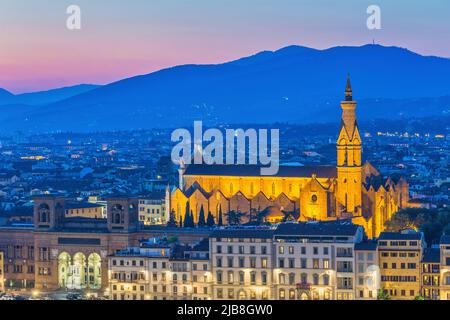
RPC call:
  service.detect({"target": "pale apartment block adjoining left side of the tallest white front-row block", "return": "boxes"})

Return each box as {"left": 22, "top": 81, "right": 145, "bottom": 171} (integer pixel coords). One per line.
{"left": 209, "top": 228, "right": 274, "bottom": 300}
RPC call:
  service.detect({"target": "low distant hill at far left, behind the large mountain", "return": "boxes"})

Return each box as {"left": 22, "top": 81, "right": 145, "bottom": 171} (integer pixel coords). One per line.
{"left": 0, "top": 84, "right": 100, "bottom": 106}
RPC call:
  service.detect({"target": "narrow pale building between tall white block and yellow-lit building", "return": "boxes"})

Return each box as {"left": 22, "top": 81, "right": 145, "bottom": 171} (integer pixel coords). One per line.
{"left": 355, "top": 241, "right": 380, "bottom": 300}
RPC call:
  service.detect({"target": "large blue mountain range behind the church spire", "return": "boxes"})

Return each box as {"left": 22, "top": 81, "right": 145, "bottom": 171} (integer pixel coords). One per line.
{"left": 0, "top": 45, "right": 450, "bottom": 131}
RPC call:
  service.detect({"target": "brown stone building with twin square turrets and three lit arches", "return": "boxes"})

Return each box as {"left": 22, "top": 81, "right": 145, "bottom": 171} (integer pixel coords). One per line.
{"left": 0, "top": 195, "right": 210, "bottom": 291}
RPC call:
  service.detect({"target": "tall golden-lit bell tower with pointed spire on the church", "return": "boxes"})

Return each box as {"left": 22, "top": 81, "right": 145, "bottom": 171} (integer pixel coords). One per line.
{"left": 336, "top": 76, "right": 362, "bottom": 216}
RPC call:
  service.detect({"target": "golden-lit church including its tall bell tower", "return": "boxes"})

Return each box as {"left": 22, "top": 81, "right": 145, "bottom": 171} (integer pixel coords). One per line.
{"left": 169, "top": 79, "right": 409, "bottom": 238}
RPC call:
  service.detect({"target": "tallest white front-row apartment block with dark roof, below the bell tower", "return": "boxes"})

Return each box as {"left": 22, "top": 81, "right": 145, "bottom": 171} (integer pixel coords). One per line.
{"left": 274, "top": 222, "right": 364, "bottom": 300}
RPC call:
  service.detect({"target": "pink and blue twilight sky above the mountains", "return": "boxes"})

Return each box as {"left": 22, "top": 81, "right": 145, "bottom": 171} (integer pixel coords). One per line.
{"left": 0, "top": 0, "right": 450, "bottom": 93}
